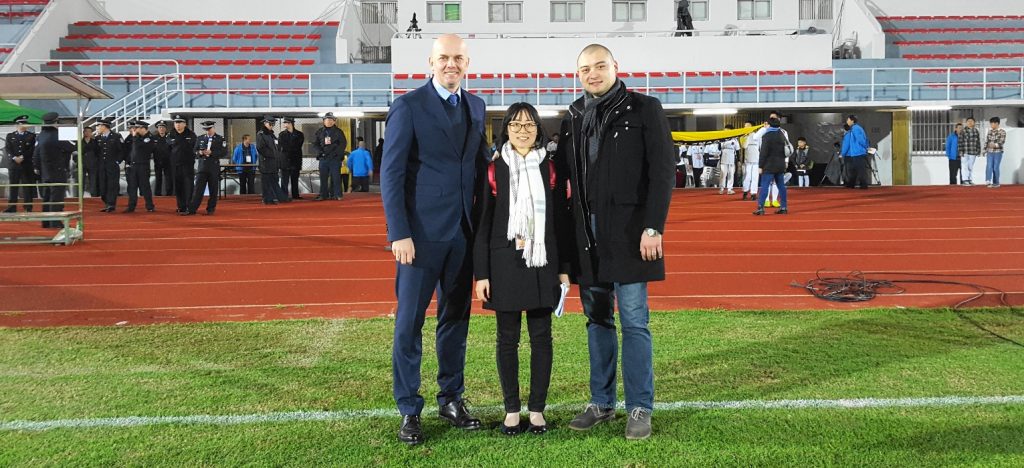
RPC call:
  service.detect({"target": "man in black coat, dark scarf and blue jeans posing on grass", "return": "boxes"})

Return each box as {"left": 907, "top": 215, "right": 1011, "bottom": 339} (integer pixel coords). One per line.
{"left": 555, "top": 44, "right": 676, "bottom": 439}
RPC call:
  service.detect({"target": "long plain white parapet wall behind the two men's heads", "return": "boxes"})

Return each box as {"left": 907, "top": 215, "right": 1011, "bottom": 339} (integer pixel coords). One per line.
{"left": 391, "top": 35, "right": 831, "bottom": 73}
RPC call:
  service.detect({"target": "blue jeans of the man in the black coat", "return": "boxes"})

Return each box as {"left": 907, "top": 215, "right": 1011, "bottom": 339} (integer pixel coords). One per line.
{"left": 580, "top": 283, "right": 654, "bottom": 410}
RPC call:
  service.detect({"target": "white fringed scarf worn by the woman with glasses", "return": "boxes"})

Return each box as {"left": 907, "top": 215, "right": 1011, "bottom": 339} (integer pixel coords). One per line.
{"left": 502, "top": 143, "right": 548, "bottom": 267}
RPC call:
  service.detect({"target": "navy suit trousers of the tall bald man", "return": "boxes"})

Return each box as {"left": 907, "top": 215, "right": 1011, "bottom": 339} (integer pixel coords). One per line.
{"left": 391, "top": 228, "right": 473, "bottom": 416}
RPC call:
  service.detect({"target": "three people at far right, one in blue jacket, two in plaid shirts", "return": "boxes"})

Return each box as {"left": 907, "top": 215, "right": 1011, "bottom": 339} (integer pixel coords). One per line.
{"left": 945, "top": 117, "right": 1007, "bottom": 188}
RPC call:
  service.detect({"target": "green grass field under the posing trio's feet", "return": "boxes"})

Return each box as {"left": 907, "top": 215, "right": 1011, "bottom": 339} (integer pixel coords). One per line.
{"left": 0, "top": 309, "right": 1024, "bottom": 467}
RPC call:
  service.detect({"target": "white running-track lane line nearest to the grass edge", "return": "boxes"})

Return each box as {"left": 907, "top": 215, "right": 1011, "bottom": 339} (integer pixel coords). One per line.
{"left": 0, "top": 288, "right": 1024, "bottom": 315}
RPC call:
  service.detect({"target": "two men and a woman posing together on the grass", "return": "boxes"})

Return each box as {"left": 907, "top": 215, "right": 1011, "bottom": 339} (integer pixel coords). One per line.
{"left": 381, "top": 35, "right": 675, "bottom": 444}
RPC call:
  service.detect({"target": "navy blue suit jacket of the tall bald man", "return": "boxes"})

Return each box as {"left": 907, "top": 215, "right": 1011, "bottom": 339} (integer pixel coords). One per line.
{"left": 381, "top": 81, "right": 487, "bottom": 242}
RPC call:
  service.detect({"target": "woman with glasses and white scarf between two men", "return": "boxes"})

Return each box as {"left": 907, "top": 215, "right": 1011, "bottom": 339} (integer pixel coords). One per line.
{"left": 473, "top": 102, "right": 569, "bottom": 435}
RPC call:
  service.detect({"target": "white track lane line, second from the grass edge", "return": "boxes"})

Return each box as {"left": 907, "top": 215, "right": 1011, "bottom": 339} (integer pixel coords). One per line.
{"left": 6, "top": 268, "right": 1024, "bottom": 289}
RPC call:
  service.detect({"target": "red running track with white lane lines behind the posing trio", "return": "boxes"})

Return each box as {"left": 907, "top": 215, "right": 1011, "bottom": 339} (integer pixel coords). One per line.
{"left": 0, "top": 185, "right": 1024, "bottom": 327}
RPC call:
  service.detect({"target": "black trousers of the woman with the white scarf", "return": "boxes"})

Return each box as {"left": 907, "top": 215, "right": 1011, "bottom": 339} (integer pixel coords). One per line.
{"left": 495, "top": 308, "right": 552, "bottom": 413}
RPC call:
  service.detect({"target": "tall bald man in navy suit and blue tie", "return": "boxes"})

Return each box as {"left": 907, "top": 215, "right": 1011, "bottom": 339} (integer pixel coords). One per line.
{"left": 381, "top": 35, "right": 487, "bottom": 444}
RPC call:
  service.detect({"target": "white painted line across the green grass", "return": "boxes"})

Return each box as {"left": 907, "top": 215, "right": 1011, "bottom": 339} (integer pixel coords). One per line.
{"left": 0, "top": 395, "right": 1024, "bottom": 432}
